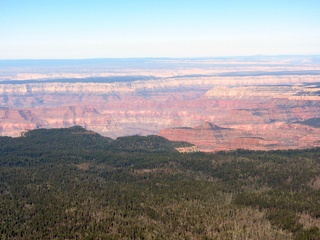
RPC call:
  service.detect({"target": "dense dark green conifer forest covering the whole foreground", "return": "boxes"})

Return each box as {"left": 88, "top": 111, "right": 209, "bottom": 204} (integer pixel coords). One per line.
{"left": 0, "top": 126, "right": 320, "bottom": 240}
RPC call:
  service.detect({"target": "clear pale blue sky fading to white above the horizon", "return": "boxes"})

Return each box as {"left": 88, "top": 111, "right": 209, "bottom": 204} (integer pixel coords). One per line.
{"left": 0, "top": 0, "right": 320, "bottom": 59}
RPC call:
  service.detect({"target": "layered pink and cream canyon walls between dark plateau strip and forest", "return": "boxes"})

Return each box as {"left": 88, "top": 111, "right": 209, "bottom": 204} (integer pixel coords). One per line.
{"left": 0, "top": 76, "right": 320, "bottom": 151}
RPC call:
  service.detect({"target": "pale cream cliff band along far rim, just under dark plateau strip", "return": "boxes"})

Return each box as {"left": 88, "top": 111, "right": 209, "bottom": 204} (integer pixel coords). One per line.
{"left": 0, "top": 76, "right": 318, "bottom": 95}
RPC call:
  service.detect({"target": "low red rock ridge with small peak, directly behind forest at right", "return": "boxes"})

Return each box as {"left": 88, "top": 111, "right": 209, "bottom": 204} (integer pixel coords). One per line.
{"left": 159, "top": 123, "right": 320, "bottom": 152}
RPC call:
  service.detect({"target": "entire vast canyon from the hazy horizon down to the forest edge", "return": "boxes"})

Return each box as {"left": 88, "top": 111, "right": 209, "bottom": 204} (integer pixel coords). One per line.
{"left": 0, "top": 57, "right": 320, "bottom": 152}
